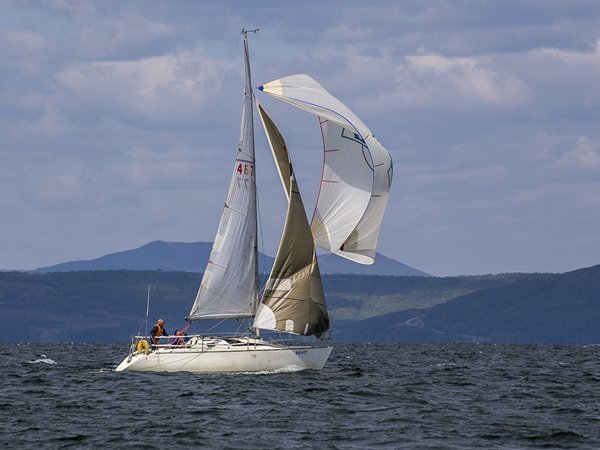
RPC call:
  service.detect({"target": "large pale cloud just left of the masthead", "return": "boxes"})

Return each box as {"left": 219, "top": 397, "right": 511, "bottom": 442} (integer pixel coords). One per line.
{"left": 56, "top": 50, "right": 231, "bottom": 122}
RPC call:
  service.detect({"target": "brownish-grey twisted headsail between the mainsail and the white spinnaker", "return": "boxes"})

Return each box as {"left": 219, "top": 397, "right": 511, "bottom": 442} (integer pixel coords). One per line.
{"left": 254, "top": 104, "right": 329, "bottom": 335}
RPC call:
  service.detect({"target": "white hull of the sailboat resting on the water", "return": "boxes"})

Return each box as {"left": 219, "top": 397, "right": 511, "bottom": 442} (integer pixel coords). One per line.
{"left": 115, "top": 339, "right": 333, "bottom": 373}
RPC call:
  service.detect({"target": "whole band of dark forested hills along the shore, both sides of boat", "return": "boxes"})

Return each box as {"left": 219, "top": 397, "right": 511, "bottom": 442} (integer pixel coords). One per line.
{"left": 0, "top": 266, "right": 600, "bottom": 344}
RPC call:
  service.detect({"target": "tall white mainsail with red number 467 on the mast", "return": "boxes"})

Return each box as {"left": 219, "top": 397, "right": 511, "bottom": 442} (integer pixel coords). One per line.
{"left": 187, "top": 36, "right": 258, "bottom": 320}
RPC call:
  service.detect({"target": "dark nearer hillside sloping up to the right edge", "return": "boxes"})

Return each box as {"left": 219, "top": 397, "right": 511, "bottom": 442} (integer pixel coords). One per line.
{"left": 338, "top": 265, "right": 600, "bottom": 344}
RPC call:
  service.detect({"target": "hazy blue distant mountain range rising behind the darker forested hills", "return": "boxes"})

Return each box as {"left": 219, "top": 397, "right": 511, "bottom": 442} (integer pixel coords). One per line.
{"left": 35, "top": 241, "right": 429, "bottom": 276}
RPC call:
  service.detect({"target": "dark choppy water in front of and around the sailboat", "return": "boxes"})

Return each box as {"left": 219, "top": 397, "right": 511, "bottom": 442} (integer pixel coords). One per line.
{"left": 0, "top": 344, "right": 600, "bottom": 449}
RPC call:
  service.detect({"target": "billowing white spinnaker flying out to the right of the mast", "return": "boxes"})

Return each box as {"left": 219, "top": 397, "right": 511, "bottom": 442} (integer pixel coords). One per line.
{"left": 259, "top": 74, "right": 392, "bottom": 264}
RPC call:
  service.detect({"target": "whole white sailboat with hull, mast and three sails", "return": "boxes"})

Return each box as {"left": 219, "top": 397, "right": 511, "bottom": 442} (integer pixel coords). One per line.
{"left": 116, "top": 30, "right": 392, "bottom": 373}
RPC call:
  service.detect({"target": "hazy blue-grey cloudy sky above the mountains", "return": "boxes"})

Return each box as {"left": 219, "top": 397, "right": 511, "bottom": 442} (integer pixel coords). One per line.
{"left": 0, "top": 0, "right": 600, "bottom": 275}
